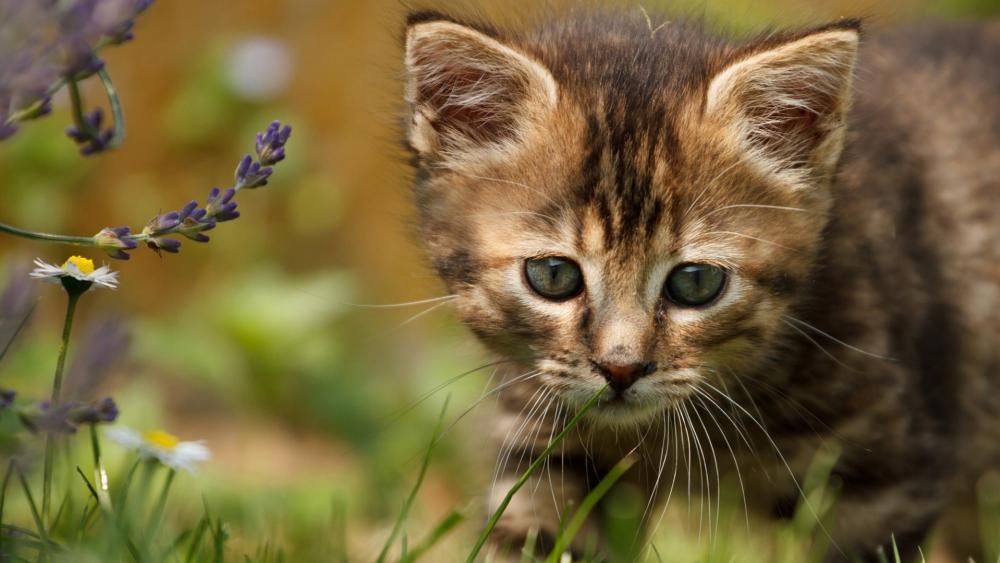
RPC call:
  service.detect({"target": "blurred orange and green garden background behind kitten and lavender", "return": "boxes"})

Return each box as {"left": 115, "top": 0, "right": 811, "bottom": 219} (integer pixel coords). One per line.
{"left": 0, "top": 0, "right": 1000, "bottom": 560}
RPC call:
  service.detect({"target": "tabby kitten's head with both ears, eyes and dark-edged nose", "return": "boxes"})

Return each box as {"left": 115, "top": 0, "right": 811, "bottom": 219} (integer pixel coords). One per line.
{"left": 406, "top": 14, "right": 858, "bottom": 424}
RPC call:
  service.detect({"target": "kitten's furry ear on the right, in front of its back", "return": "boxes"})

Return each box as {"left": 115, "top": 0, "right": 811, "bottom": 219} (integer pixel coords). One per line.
{"left": 706, "top": 21, "right": 859, "bottom": 179}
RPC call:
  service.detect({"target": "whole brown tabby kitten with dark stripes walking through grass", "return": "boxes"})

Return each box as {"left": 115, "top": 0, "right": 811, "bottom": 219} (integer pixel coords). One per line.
{"left": 405, "top": 8, "right": 1000, "bottom": 560}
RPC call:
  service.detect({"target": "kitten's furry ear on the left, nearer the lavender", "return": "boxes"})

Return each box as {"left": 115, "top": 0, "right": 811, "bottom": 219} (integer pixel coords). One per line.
{"left": 406, "top": 16, "right": 557, "bottom": 160}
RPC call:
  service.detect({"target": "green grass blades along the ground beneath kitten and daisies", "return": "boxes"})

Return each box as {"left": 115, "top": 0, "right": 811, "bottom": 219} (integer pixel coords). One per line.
{"left": 0, "top": 382, "right": 1000, "bottom": 563}
